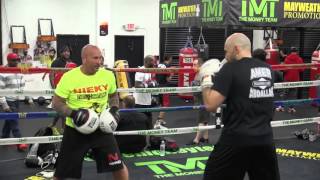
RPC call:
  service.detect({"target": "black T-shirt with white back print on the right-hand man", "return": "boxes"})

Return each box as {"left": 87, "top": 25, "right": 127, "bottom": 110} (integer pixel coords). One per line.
{"left": 212, "top": 58, "right": 274, "bottom": 145}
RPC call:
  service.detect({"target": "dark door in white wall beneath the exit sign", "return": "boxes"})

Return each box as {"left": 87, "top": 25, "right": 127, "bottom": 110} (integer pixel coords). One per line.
{"left": 114, "top": 36, "right": 144, "bottom": 84}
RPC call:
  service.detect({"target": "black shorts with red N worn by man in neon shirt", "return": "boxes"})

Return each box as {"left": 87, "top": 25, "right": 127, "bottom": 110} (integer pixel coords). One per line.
{"left": 54, "top": 126, "right": 123, "bottom": 179}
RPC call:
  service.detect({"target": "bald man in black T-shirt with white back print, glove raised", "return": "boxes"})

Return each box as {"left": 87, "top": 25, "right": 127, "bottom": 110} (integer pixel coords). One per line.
{"left": 200, "top": 33, "right": 280, "bottom": 180}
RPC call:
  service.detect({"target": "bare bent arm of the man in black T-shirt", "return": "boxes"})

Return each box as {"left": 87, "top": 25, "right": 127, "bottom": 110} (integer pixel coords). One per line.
{"left": 202, "top": 88, "right": 225, "bottom": 112}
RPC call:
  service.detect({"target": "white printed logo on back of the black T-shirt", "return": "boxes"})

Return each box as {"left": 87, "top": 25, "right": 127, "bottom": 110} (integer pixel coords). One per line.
{"left": 249, "top": 67, "right": 274, "bottom": 98}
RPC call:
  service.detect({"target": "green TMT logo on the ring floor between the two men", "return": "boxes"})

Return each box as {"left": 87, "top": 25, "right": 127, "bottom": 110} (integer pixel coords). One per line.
{"left": 135, "top": 157, "right": 208, "bottom": 179}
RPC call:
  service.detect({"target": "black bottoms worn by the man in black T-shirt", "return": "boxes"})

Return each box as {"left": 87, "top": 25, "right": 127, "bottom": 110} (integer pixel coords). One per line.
{"left": 203, "top": 144, "right": 280, "bottom": 180}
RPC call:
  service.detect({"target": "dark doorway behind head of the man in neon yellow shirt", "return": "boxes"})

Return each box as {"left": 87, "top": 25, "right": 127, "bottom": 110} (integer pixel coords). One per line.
{"left": 57, "top": 34, "right": 89, "bottom": 65}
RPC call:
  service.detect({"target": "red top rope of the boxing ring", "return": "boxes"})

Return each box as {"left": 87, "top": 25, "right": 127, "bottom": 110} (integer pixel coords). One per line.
{"left": 0, "top": 63, "right": 320, "bottom": 74}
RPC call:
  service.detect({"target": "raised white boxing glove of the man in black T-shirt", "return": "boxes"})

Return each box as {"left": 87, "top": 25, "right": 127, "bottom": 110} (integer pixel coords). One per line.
{"left": 199, "top": 59, "right": 220, "bottom": 88}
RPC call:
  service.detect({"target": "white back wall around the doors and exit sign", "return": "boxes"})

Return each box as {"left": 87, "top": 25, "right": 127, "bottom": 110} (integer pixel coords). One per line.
{"left": 1, "top": 0, "right": 159, "bottom": 66}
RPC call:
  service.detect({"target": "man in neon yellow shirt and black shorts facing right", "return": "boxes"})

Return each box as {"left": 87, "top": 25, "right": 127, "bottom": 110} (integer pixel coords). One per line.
{"left": 52, "top": 45, "right": 129, "bottom": 180}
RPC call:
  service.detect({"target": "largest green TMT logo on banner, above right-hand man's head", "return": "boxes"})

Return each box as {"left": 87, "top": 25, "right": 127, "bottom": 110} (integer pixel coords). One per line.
{"left": 239, "top": 0, "right": 279, "bottom": 23}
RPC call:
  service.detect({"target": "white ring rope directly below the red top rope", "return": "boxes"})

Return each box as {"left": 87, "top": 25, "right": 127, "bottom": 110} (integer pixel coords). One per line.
{"left": 0, "top": 80, "right": 320, "bottom": 97}
